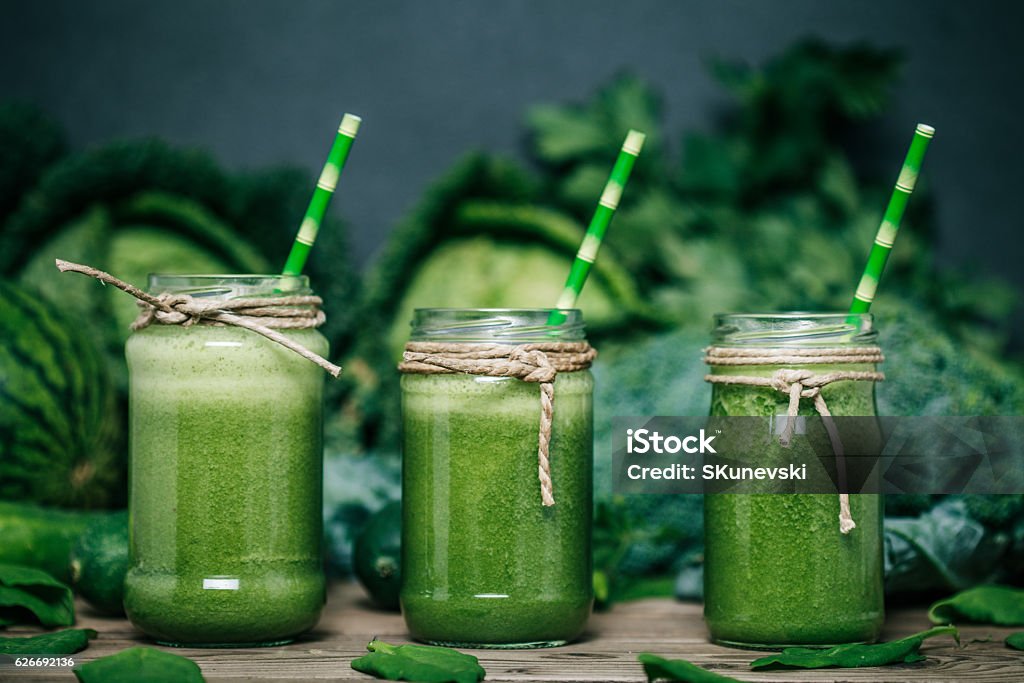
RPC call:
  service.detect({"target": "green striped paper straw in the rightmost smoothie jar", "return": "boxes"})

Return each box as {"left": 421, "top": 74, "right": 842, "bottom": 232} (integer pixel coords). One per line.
{"left": 850, "top": 123, "right": 935, "bottom": 313}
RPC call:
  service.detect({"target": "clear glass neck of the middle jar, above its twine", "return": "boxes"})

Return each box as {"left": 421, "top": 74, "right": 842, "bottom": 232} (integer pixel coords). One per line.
{"left": 410, "top": 308, "right": 587, "bottom": 344}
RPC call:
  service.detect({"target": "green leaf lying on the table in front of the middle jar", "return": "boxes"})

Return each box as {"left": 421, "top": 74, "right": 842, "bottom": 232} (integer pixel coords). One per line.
{"left": 352, "top": 640, "right": 486, "bottom": 683}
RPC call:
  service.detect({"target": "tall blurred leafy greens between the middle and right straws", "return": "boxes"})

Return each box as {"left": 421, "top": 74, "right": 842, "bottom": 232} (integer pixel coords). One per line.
{"left": 527, "top": 40, "right": 1016, "bottom": 362}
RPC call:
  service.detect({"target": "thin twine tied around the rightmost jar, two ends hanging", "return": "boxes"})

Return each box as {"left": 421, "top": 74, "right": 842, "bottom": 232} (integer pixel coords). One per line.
{"left": 705, "top": 346, "right": 886, "bottom": 533}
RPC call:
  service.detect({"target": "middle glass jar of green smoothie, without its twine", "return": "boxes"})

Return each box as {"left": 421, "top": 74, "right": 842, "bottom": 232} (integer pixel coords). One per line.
{"left": 401, "top": 309, "right": 594, "bottom": 648}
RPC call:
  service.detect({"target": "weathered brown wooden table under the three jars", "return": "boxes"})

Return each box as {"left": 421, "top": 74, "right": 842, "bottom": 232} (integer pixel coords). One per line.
{"left": 0, "top": 584, "right": 1024, "bottom": 683}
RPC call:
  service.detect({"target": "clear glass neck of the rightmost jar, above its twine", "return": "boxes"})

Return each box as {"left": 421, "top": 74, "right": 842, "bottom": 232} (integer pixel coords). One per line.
{"left": 712, "top": 312, "right": 878, "bottom": 347}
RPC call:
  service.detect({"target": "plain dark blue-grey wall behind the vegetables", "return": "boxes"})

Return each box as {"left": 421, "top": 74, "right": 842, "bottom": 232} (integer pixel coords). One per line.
{"left": 0, "top": 0, "right": 1024, "bottom": 319}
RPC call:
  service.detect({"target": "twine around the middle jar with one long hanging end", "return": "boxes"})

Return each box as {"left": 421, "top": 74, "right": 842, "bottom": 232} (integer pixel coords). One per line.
{"left": 398, "top": 342, "right": 597, "bottom": 507}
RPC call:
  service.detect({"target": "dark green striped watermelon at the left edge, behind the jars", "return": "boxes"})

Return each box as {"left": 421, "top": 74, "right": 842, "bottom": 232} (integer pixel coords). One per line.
{"left": 0, "top": 276, "right": 123, "bottom": 507}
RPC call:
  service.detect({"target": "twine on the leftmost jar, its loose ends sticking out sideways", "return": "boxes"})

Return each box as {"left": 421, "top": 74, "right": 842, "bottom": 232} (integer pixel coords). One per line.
{"left": 56, "top": 259, "right": 341, "bottom": 377}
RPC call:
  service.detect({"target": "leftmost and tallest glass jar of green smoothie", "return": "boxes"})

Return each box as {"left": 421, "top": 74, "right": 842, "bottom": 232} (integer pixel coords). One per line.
{"left": 125, "top": 275, "right": 328, "bottom": 647}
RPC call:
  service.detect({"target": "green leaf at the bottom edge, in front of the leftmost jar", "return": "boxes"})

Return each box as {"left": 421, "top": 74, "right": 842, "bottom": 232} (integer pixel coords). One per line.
{"left": 73, "top": 647, "right": 206, "bottom": 683}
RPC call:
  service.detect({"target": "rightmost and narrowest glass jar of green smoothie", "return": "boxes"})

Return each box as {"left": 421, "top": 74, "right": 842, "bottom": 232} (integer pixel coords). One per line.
{"left": 705, "top": 313, "right": 884, "bottom": 648}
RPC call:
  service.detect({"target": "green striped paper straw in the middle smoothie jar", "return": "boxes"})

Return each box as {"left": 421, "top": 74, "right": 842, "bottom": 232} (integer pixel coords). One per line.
{"left": 548, "top": 130, "right": 647, "bottom": 325}
